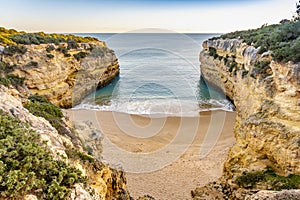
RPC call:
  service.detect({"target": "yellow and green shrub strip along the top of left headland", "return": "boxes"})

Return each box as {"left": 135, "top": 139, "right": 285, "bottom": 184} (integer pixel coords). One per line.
{"left": 0, "top": 27, "right": 98, "bottom": 46}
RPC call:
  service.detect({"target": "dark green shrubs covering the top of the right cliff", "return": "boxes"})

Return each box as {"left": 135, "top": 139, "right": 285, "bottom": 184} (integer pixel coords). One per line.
{"left": 212, "top": 20, "right": 300, "bottom": 62}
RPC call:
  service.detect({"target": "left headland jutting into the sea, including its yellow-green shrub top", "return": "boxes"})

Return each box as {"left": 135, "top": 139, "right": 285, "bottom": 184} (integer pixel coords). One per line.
{"left": 0, "top": 28, "right": 119, "bottom": 108}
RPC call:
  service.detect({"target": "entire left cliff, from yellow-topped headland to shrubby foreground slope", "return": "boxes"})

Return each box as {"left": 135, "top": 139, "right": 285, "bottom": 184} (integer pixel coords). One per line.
{"left": 0, "top": 28, "right": 131, "bottom": 200}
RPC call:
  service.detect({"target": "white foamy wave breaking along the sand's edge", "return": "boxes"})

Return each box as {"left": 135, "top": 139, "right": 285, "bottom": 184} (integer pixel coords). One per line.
{"left": 72, "top": 99, "right": 235, "bottom": 117}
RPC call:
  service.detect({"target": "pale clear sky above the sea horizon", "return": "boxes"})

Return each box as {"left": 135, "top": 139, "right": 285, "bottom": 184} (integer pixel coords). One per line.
{"left": 0, "top": 0, "right": 296, "bottom": 33}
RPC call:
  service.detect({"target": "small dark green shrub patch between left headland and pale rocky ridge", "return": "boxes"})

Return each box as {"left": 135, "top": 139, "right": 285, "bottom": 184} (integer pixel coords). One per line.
{"left": 24, "top": 95, "right": 69, "bottom": 134}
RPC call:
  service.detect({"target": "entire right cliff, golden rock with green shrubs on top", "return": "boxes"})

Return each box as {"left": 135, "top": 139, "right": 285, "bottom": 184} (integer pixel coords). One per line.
{"left": 192, "top": 22, "right": 300, "bottom": 199}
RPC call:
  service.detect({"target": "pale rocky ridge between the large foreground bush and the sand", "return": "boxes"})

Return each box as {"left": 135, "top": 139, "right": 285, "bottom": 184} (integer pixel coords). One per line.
{"left": 0, "top": 85, "right": 130, "bottom": 200}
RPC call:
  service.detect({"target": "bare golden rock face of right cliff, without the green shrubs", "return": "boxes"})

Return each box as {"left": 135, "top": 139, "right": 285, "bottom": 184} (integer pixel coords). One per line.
{"left": 200, "top": 39, "right": 300, "bottom": 179}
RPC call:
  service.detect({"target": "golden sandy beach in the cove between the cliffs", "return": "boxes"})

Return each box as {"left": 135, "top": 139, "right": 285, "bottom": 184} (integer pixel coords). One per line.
{"left": 68, "top": 110, "right": 235, "bottom": 200}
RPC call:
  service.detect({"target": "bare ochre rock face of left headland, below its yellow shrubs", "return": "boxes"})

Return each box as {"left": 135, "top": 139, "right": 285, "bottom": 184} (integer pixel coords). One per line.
{"left": 1, "top": 41, "right": 119, "bottom": 108}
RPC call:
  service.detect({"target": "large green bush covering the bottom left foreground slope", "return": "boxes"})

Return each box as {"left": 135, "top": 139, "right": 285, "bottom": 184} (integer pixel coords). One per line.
{"left": 0, "top": 110, "right": 85, "bottom": 199}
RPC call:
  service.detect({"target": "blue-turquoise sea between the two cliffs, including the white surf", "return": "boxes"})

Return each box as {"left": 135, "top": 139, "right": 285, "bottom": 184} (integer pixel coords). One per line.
{"left": 76, "top": 33, "right": 233, "bottom": 116}
